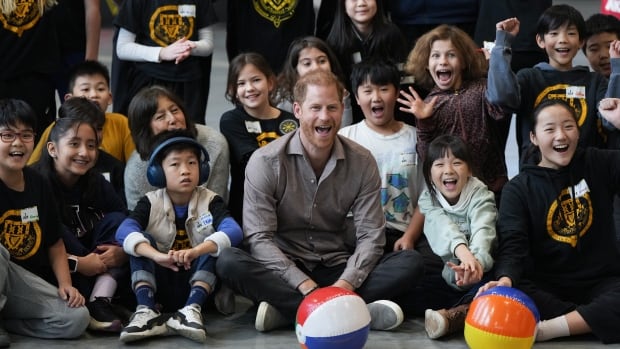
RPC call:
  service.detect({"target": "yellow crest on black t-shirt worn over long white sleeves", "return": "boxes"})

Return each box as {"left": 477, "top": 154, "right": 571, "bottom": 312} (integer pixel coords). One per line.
{"left": 149, "top": 5, "right": 194, "bottom": 47}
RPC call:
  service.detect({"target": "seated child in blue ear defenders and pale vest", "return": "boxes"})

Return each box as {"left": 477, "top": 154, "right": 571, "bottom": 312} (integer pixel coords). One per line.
{"left": 116, "top": 130, "right": 243, "bottom": 342}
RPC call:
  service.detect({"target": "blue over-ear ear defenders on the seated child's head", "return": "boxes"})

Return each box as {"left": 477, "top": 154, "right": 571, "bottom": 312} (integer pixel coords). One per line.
{"left": 146, "top": 137, "right": 210, "bottom": 188}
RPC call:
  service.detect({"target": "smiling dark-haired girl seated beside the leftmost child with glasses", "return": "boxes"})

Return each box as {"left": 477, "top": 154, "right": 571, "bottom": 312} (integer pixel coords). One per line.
{"left": 33, "top": 97, "right": 129, "bottom": 332}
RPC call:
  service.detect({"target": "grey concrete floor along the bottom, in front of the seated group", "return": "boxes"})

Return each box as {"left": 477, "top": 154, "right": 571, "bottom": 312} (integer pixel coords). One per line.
{"left": 11, "top": 302, "right": 620, "bottom": 349}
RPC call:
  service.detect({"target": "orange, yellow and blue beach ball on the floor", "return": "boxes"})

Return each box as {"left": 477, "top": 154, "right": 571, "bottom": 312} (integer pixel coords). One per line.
{"left": 465, "top": 286, "right": 540, "bottom": 349}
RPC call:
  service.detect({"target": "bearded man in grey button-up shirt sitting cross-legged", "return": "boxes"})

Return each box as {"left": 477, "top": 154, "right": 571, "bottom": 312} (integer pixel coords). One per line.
{"left": 216, "top": 72, "right": 423, "bottom": 331}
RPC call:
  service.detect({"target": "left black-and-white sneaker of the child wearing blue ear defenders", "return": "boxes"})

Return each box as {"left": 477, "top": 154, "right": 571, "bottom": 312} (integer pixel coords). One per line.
{"left": 120, "top": 305, "right": 168, "bottom": 343}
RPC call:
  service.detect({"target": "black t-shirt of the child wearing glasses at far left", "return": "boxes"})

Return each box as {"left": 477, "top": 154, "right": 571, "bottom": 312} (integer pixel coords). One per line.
{"left": 0, "top": 168, "right": 61, "bottom": 283}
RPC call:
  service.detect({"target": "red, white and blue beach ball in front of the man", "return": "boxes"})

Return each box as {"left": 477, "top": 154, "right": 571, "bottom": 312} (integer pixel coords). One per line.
{"left": 295, "top": 286, "right": 370, "bottom": 349}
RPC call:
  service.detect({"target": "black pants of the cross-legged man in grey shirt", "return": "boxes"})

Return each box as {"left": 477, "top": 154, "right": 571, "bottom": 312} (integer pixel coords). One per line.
{"left": 216, "top": 248, "right": 423, "bottom": 323}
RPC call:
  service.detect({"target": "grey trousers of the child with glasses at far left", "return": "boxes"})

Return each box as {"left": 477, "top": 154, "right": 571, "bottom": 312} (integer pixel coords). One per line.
{"left": 0, "top": 245, "right": 90, "bottom": 338}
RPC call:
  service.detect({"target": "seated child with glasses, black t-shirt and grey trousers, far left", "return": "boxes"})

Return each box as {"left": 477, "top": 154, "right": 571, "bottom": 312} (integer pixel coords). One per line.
{"left": 0, "top": 99, "right": 90, "bottom": 347}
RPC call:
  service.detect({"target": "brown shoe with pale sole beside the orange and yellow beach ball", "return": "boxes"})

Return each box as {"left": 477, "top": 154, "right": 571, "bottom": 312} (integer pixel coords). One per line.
{"left": 424, "top": 304, "right": 469, "bottom": 339}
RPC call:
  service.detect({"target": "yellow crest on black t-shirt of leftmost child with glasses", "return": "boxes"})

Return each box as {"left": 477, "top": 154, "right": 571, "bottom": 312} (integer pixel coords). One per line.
{"left": 0, "top": 210, "right": 41, "bottom": 260}
